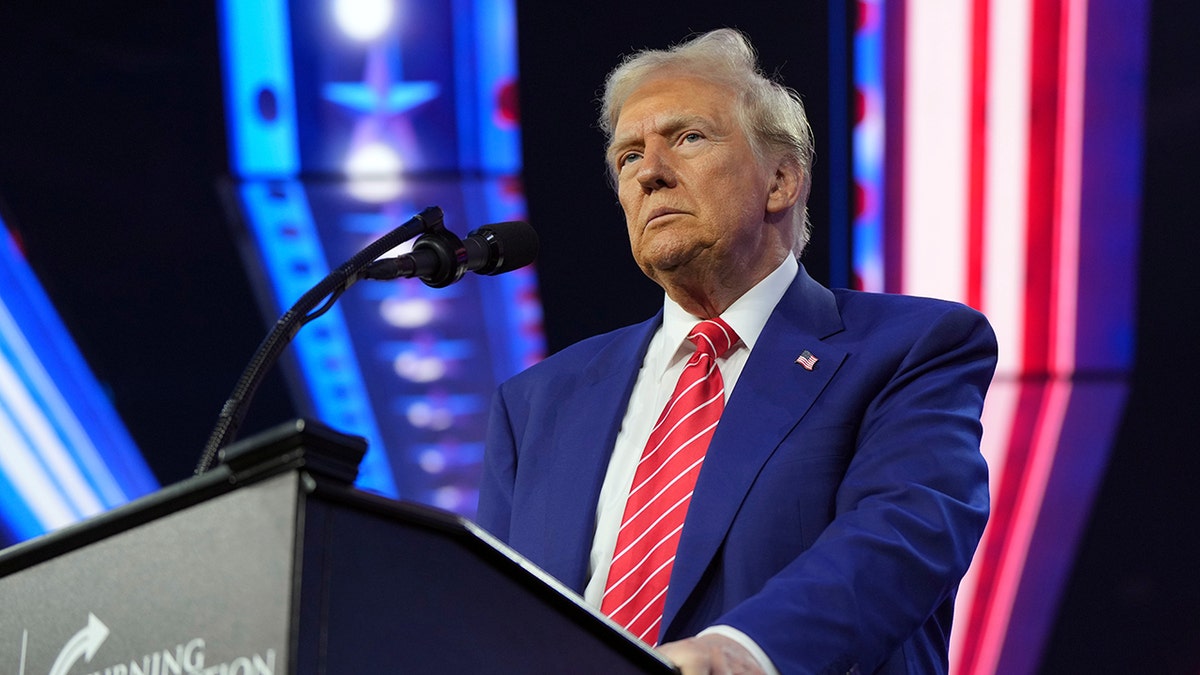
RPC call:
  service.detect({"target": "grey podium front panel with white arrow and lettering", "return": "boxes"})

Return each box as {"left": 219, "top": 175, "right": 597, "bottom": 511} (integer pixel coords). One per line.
{"left": 0, "top": 473, "right": 298, "bottom": 675}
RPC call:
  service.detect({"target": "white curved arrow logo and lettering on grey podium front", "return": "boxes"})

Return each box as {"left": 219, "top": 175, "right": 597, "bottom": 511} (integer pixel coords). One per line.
{"left": 18, "top": 611, "right": 275, "bottom": 675}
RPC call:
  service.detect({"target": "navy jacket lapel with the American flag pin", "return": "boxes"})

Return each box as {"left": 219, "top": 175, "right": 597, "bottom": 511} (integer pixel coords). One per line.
{"left": 662, "top": 267, "right": 846, "bottom": 634}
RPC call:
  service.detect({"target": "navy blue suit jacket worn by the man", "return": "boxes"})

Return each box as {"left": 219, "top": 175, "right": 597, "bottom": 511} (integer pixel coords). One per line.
{"left": 478, "top": 268, "right": 996, "bottom": 674}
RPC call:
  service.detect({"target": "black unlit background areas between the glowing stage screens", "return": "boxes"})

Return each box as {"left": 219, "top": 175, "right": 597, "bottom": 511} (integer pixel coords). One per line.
{"left": 0, "top": 0, "right": 1200, "bottom": 674}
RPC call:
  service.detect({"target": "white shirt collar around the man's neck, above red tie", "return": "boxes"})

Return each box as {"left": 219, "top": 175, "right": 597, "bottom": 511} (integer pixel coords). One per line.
{"left": 659, "top": 256, "right": 800, "bottom": 365}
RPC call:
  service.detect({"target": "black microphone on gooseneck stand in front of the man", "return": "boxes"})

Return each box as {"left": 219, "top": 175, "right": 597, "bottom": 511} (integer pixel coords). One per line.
{"left": 362, "top": 221, "right": 538, "bottom": 288}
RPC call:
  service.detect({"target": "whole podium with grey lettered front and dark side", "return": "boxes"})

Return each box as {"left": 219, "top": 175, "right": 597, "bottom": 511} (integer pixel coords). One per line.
{"left": 0, "top": 420, "right": 676, "bottom": 675}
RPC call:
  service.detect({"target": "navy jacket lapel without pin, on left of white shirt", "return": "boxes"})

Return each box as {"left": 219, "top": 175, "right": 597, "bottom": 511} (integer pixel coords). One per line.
{"left": 544, "top": 311, "right": 662, "bottom": 592}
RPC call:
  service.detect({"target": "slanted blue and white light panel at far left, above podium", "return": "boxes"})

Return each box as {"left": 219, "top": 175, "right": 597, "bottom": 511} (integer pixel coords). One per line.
{"left": 0, "top": 222, "right": 158, "bottom": 544}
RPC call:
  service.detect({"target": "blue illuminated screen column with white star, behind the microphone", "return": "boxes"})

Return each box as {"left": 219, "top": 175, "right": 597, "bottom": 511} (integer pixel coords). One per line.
{"left": 221, "top": 0, "right": 544, "bottom": 515}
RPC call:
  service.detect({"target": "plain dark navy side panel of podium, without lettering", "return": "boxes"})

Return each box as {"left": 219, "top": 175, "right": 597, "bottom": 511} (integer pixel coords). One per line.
{"left": 296, "top": 487, "right": 670, "bottom": 675}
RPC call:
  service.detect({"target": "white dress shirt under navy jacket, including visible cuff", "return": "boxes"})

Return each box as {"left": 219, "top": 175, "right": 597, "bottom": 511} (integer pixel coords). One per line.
{"left": 583, "top": 256, "right": 799, "bottom": 674}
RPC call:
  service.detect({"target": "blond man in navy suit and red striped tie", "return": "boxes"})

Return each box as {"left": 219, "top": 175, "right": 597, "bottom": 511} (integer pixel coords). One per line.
{"left": 479, "top": 30, "right": 996, "bottom": 674}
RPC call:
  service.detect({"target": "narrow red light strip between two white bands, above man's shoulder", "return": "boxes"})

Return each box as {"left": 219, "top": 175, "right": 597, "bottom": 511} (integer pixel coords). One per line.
{"left": 966, "top": 0, "right": 991, "bottom": 310}
